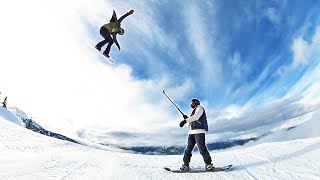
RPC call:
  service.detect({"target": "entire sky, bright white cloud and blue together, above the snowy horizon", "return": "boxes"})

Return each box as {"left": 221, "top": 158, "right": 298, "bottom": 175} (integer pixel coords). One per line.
{"left": 0, "top": 0, "right": 320, "bottom": 147}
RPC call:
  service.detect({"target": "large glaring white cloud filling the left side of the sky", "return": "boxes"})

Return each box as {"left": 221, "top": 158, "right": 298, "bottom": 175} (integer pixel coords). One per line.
{"left": 0, "top": 0, "right": 189, "bottom": 141}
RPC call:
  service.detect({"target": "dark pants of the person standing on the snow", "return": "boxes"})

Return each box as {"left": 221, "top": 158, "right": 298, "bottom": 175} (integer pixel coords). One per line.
{"left": 183, "top": 133, "right": 212, "bottom": 164}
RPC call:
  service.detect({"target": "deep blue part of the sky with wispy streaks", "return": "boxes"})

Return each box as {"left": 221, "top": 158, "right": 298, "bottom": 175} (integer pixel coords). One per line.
{"left": 85, "top": 1, "right": 319, "bottom": 108}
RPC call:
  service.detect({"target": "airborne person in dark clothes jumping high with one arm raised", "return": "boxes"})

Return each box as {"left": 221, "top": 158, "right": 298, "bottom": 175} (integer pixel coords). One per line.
{"left": 95, "top": 9, "right": 134, "bottom": 58}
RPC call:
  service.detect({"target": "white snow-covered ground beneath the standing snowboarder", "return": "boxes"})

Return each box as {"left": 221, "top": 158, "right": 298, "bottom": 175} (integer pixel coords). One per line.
{"left": 0, "top": 107, "right": 320, "bottom": 180}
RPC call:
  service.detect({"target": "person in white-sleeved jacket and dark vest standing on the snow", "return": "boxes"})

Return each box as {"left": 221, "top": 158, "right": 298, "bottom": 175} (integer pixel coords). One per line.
{"left": 179, "top": 99, "right": 214, "bottom": 171}
